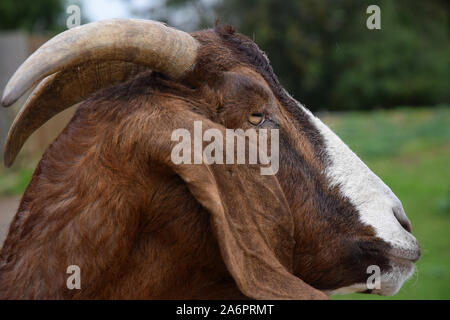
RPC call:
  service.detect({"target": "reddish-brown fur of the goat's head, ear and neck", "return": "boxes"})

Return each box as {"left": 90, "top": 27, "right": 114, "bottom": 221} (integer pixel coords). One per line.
{"left": 0, "top": 26, "right": 388, "bottom": 299}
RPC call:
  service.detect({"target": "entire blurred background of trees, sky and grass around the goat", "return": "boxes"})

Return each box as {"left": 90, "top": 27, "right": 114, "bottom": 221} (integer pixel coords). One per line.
{"left": 0, "top": 0, "right": 450, "bottom": 299}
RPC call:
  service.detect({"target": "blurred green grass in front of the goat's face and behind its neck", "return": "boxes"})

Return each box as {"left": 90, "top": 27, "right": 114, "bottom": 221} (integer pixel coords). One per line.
{"left": 0, "top": 106, "right": 450, "bottom": 299}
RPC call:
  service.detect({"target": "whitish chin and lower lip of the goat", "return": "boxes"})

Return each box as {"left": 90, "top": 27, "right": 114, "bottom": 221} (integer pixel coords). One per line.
{"left": 324, "top": 259, "right": 414, "bottom": 296}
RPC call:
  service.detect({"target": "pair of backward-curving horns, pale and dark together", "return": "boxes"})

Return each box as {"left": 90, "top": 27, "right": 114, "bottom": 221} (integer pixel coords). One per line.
{"left": 2, "top": 19, "right": 199, "bottom": 166}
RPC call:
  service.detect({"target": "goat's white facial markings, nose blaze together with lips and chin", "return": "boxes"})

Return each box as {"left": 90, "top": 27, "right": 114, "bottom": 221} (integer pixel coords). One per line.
{"left": 286, "top": 91, "right": 420, "bottom": 295}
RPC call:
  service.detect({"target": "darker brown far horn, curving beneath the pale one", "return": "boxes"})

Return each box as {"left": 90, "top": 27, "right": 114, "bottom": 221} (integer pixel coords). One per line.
{"left": 3, "top": 61, "right": 148, "bottom": 167}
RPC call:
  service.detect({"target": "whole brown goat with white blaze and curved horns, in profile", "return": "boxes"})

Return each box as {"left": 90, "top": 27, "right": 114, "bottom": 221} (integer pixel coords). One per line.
{"left": 0, "top": 19, "right": 420, "bottom": 299}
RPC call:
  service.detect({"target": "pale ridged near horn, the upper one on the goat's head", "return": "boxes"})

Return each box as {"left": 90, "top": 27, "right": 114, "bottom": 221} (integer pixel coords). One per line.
{"left": 2, "top": 19, "right": 199, "bottom": 106}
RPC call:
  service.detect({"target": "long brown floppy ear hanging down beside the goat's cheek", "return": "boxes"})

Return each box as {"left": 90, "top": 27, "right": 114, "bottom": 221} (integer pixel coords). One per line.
{"left": 151, "top": 103, "right": 327, "bottom": 299}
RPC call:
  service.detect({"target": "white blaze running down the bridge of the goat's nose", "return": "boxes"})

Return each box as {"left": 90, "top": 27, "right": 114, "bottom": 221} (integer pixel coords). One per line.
{"left": 304, "top": 104, "right": 418, "bottom": 251}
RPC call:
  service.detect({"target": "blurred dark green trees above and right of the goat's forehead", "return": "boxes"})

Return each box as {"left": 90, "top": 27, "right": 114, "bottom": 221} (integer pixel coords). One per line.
{"left": 143, "top": 0, "right": 450, "bottom": 110}
